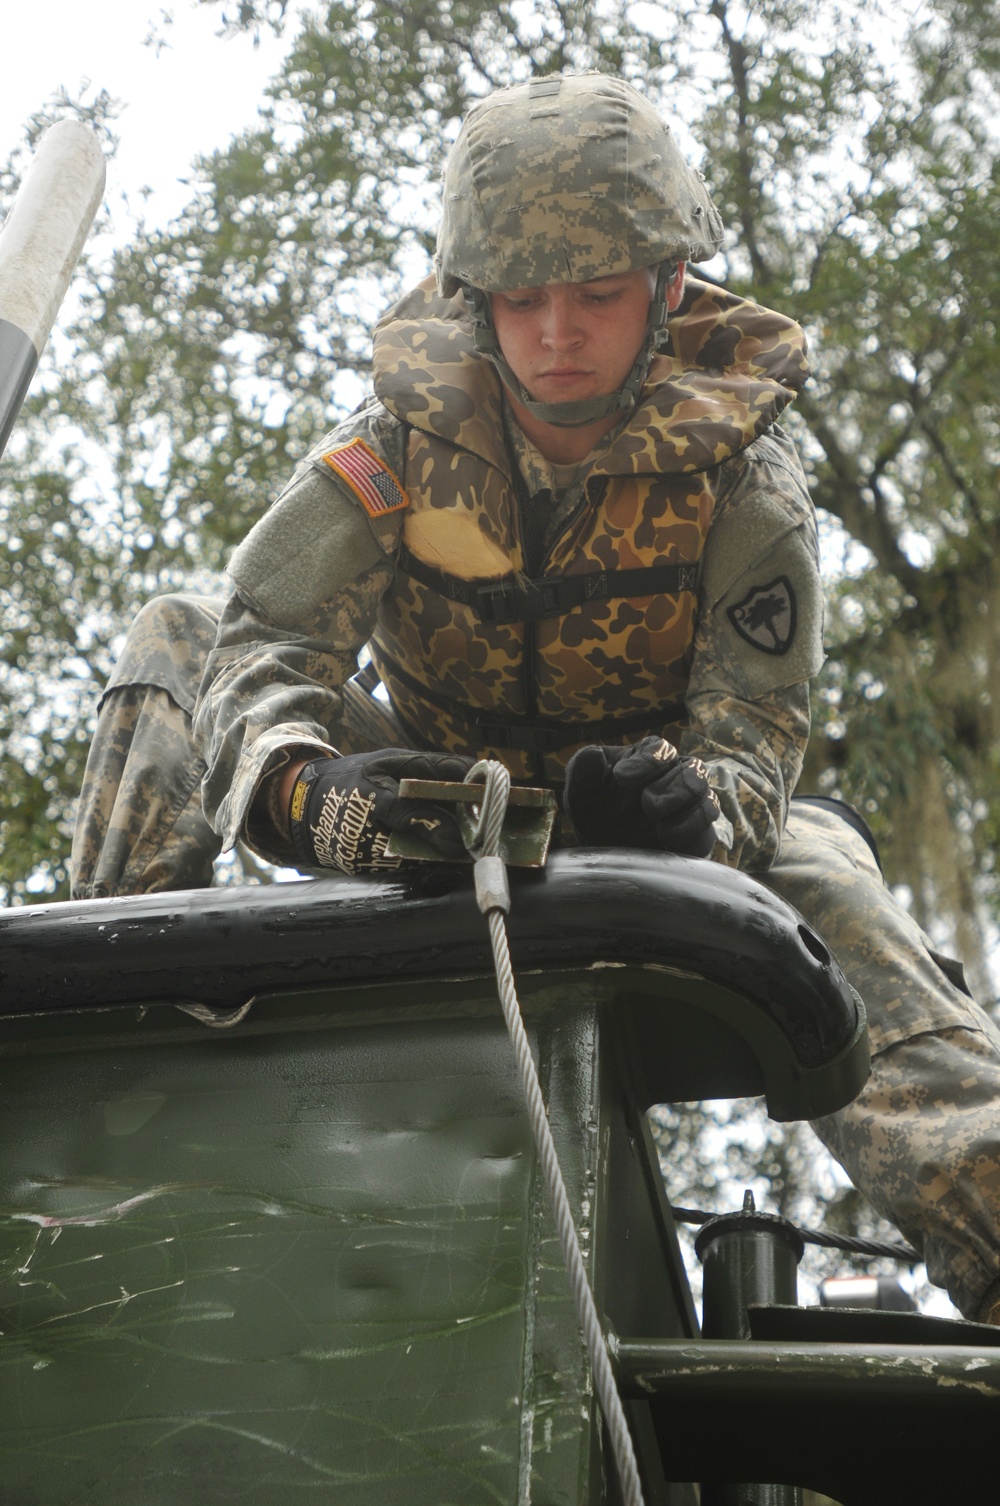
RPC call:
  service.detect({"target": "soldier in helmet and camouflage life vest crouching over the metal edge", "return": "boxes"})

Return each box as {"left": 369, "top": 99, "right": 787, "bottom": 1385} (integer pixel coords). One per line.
{"left": 72, "top": 74, "right": 1000, "bottom": 1318}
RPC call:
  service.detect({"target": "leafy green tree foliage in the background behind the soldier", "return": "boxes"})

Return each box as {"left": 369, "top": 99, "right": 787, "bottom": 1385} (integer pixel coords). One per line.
{"left": 0, "top": 0, "right": 1000, "bottom": 1012}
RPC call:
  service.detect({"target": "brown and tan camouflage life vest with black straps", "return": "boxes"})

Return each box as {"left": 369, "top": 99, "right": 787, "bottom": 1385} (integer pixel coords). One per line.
{"left": 362, "top": 279, "right": 807, "bottom": 782}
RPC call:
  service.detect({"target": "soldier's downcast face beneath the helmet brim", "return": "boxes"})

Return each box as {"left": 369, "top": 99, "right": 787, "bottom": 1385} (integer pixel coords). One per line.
{"left": 489, "top": 267, "right": 655, "bottom": 402}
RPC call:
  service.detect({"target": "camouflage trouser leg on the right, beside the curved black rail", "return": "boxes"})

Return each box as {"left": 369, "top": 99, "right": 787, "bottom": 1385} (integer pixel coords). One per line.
{"left": 755, "top": 801, "right": 1000, "bottom": 1318}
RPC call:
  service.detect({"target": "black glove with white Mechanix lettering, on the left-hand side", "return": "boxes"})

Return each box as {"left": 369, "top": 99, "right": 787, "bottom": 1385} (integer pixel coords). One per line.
{"left": 289, "top": 748, "right": 474, "bottom": 873}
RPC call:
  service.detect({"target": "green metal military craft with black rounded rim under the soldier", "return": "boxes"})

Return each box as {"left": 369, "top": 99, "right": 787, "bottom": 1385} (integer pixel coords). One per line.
{"left": 0, "top": 851, "right": 1000, "bottom": 1506}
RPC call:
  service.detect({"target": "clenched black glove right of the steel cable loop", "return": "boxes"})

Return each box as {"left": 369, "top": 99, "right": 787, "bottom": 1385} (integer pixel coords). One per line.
{"left": 563, "top": 738, "right": 721, "bottom": 857}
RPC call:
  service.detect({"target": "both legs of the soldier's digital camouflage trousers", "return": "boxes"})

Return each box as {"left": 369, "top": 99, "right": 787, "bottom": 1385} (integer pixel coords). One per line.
{"left": 72, "top": 596, "right": 1000, "bottom": 1318}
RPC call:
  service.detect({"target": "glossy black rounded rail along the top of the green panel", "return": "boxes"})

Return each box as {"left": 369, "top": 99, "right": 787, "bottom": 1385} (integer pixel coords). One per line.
{"left": 0, "top": 848, "right": 864, "bottom": 1096}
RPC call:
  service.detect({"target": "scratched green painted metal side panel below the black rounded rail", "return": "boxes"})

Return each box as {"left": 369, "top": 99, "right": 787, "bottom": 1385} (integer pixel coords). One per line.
{"left": 0, "top": 983, "right": 691, "bottom": 1506}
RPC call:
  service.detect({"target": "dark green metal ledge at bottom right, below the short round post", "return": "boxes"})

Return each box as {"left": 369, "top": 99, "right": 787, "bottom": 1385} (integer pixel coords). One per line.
{"left": 617, "top": 1343, "right": 1000, "bottom": 1506}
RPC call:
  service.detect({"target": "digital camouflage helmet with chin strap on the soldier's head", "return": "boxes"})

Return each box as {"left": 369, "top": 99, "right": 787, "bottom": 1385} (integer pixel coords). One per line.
{"left": 435, "top": 74, "right": 723, "bottom": 428}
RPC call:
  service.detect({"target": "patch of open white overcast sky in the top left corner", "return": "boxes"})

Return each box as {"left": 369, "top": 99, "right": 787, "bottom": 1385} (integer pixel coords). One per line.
{"left": 0, "top": 0, "right": 294, "bottom": 233}
